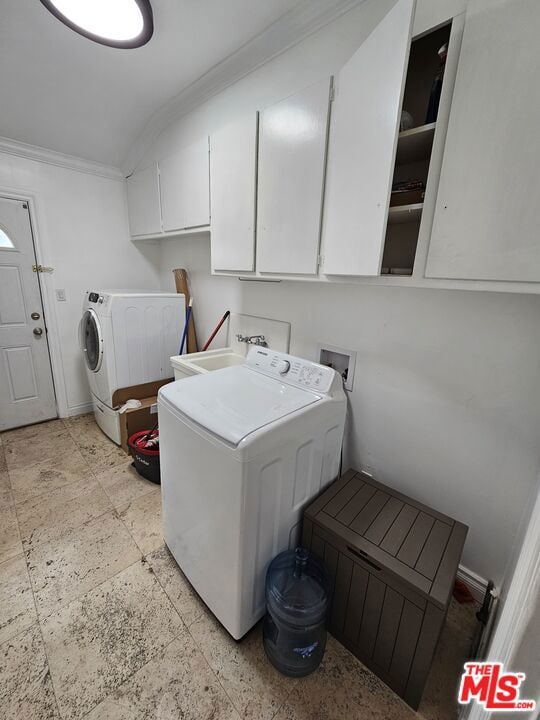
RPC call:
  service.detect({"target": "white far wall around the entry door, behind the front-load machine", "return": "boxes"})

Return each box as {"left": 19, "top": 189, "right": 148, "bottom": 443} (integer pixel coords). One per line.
{"left": 0, "top": 153, "right": 159, "bottom": 415}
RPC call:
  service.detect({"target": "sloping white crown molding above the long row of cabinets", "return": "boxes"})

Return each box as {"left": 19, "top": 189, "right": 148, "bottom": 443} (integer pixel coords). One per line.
{"left": 122, "top": 0, "right": 364, "bottom": 175}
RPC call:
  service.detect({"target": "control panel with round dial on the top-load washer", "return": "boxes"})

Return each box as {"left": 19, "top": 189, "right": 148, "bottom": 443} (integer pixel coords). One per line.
{"left": 246, "top": 347, "right": 337, "bottom": 393}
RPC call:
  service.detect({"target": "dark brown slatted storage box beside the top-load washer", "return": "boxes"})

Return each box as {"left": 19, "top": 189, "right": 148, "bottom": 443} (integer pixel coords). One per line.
{"left": 302, "top": 470, "right": 467, "bottom": 709}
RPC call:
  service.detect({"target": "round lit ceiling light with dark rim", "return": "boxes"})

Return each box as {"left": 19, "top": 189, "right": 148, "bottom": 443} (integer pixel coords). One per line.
{"left": 41, "top": 0, "right": 154, "bottom": 48}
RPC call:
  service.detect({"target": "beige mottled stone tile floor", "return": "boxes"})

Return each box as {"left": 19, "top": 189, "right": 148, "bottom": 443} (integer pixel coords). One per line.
{"left": 0, "top": 416, "right": 474, "bottom": 720}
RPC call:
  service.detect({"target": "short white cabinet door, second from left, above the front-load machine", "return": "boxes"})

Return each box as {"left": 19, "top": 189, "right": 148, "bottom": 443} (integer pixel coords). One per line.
{"left": 159, "top": 137, "right": 210, "bottom": 232}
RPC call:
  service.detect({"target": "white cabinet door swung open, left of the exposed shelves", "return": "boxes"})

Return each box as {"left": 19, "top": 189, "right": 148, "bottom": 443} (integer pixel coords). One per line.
{"left": 323, "top": 0, "right": 414, "bottom": 275}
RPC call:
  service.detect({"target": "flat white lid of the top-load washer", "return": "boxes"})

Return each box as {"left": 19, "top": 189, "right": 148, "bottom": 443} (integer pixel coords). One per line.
{"left": 160, "top": 365, "right": 322, "bottom": 446}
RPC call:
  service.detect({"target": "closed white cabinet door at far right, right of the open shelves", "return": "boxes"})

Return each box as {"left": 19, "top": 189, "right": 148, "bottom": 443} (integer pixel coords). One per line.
{"left": 426, "top": 0, "right": 540, "bottom": 282}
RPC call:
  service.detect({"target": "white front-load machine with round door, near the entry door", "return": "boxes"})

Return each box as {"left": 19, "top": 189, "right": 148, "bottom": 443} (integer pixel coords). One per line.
{"left": 79, "top": 290, "right": 185, "bottom": 444}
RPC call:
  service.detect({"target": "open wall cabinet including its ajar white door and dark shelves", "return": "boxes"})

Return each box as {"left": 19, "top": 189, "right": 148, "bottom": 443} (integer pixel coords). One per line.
{"left": 320, "top": 0, "right": 463, "bottom": 285}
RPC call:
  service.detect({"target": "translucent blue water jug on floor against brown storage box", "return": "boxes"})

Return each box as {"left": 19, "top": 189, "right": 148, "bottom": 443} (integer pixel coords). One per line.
{"left": 263, "top": 548, "right": 330, "bottom": 677}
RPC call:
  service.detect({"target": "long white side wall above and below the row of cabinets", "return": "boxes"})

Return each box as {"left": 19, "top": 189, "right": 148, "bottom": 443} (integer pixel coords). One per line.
{"left": 136, "top": 0, "right": 540, "bottom": 583}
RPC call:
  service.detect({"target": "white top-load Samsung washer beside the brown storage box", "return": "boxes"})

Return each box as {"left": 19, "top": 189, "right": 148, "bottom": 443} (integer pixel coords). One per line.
{"left": 158, "top": 347, "right": 346, "bottom": 639}
